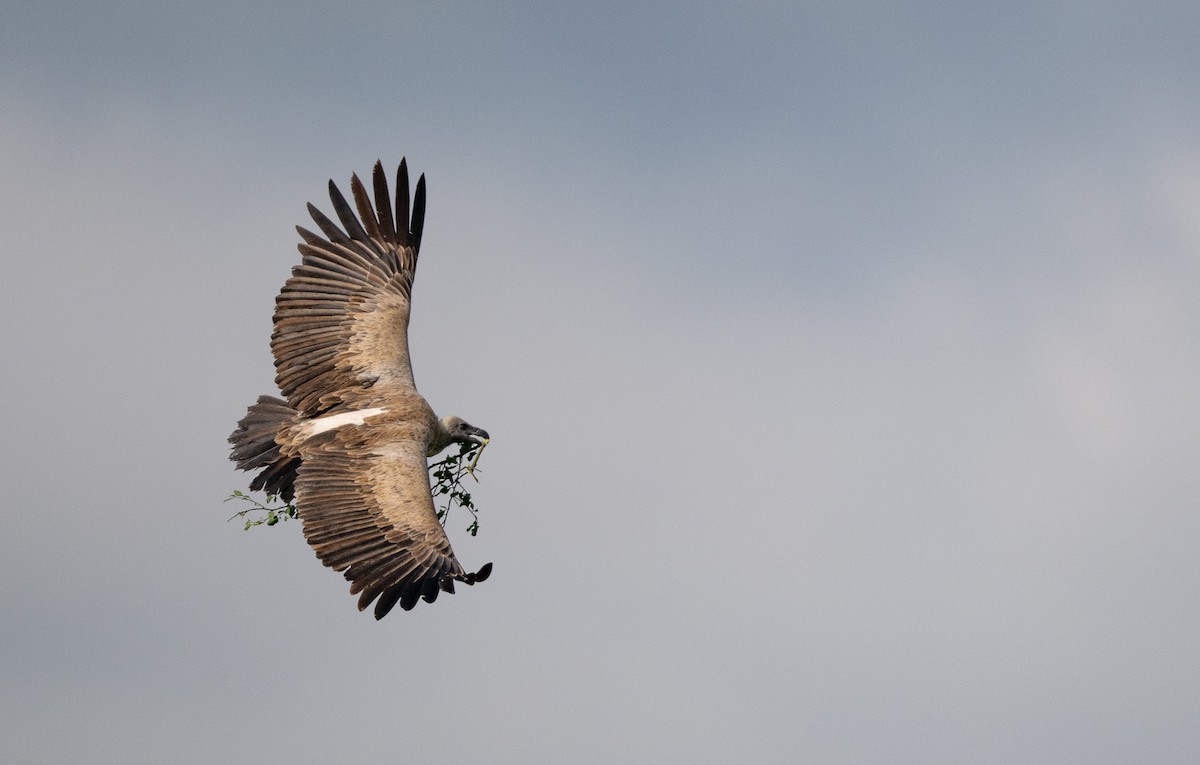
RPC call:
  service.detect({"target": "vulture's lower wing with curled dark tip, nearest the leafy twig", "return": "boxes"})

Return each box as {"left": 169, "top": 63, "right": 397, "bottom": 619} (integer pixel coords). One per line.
{"left": 296, "top": 435, "right": 468, "bottom": 619}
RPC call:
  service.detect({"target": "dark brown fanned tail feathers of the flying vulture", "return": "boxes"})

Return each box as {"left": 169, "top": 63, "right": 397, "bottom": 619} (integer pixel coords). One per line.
{"left": 229, "top": 396, "right": 300, "bottom": 502}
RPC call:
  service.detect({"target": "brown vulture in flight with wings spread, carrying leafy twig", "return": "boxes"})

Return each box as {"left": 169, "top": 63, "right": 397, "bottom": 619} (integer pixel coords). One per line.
{"left": 229, "top": 159, "right": 492, "bottom": 619}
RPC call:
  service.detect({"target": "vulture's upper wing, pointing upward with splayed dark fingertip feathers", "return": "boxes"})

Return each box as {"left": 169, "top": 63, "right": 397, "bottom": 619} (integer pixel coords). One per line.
{"left": 271, "top": 159, "right": 425, "bottom": 416}
